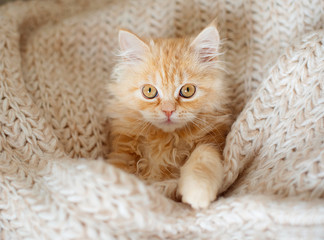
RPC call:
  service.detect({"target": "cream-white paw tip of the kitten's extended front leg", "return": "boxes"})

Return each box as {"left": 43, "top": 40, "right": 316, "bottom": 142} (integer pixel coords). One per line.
{"left": 178, "top": 178, "right": 217, "bottom": 209}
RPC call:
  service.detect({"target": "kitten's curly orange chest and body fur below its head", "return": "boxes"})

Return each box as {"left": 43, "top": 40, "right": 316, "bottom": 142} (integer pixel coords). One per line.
{"left": 110, "top": 110, "right": 228, "bottom": 181}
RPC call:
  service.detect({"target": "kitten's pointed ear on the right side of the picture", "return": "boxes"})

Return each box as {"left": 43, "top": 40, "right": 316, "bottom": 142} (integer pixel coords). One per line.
{"left": 190, "top": 24, "right": 220, "bottom": 62}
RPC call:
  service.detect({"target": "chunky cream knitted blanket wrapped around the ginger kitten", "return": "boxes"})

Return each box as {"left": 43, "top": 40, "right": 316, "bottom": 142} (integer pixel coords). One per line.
{"left": 0, "top": 0, "right": 324, "bottom": 239}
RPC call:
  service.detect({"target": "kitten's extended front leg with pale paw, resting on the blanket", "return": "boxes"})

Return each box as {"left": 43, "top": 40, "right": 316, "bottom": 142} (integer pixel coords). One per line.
{"left": 179, "top": 144, "right": 224, "bottom": 209}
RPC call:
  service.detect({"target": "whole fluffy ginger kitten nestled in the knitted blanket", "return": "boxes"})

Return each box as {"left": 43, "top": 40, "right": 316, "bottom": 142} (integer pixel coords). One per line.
{"left": 107, "top": 24, "right": 232, "bottom": 209}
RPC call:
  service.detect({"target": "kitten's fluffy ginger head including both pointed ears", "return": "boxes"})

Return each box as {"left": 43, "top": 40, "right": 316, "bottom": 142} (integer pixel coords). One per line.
{"left": 108, "top": 25, "right": 227, "bottom": 132}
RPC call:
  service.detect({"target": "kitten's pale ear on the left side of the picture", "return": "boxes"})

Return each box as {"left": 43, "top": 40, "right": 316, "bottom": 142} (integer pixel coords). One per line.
{"left": 119, "top": 30, "right": 149, "bottom": 63}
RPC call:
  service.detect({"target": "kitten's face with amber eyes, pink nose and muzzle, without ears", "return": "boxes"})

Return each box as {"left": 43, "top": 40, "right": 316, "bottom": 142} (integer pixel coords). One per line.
{"left": 134, "top": 67, "right": 207, "bottom": 132}
